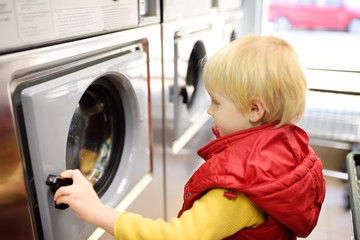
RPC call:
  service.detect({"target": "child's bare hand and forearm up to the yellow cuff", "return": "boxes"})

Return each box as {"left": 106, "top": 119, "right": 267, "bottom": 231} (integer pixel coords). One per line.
{"left": 54, "top": 170, "right": 120, "bottom": 234}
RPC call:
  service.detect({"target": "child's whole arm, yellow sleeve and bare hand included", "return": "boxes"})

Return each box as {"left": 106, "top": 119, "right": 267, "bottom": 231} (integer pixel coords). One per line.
{"left": 54, "top": 170, "right": 265, "bottom": 240}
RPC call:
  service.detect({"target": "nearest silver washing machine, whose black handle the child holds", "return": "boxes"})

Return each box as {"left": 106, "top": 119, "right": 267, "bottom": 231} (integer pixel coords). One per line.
{"left": 0, "top": 0, "right": 163, "bottom": 239}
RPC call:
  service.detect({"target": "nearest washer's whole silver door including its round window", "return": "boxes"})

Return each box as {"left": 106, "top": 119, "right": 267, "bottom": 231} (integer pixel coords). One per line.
{"left": 20, "top": 47, "right": 152, "bottom": 239}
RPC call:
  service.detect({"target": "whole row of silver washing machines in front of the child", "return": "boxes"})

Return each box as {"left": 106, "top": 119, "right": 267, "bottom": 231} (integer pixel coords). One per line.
{"left": 0, "top": 0, "right": 253, "bottom": 239}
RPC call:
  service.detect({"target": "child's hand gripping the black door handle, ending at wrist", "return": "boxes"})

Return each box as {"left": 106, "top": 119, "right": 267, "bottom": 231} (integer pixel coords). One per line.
{"left": 54, "top": 169, "right": 104, "bottom": 222}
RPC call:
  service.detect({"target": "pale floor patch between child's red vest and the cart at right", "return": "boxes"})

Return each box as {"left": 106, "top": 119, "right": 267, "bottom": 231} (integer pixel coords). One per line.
{"left": 300, "top": 177, "right": 353, "bottom": 240}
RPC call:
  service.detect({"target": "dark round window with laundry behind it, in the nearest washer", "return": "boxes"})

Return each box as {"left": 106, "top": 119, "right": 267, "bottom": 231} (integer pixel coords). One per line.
{"left": 66, "top": 78, "right": 125, "bottom": 195}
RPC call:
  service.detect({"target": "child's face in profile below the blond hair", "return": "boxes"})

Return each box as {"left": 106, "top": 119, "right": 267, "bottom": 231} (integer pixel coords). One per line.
{"left": 207, "top": 91, "right": 254, "bottom": 136}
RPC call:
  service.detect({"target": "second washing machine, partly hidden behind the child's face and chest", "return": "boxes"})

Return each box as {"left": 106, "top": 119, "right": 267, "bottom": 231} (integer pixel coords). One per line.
{"left": 161, "top": 7, "right": 226, "bottom": 220}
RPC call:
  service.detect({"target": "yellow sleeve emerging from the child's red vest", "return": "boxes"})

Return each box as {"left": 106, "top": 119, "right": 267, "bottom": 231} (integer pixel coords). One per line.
{"left": 114, "top": 188, "right": 265, "bottom": 240}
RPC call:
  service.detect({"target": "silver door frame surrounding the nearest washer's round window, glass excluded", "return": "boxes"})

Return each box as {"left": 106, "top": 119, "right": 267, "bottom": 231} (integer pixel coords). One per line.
{"left": 21, "top": 52, "right": 151, "bottom": 239}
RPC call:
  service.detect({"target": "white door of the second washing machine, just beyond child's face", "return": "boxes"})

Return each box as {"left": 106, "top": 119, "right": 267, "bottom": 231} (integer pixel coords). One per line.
{"left": 170, "top": 24, "right": 217, "bottom": 153}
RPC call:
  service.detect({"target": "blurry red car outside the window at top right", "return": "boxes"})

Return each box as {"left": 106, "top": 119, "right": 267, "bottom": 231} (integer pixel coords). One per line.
{"left": 268, "top": 0, "right": 360, "bottom": 33}
